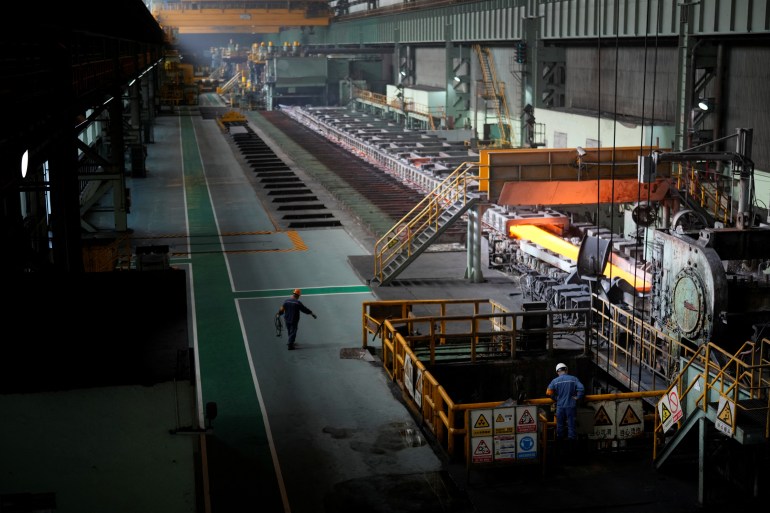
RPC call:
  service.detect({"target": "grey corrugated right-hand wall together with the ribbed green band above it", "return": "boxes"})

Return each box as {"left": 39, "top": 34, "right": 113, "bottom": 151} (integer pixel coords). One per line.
{"left": 290, "top": 0, "right": 770, "bottom": 176}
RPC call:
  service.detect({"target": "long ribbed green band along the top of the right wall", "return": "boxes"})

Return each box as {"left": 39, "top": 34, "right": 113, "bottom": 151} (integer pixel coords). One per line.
{"left": 313, "top": 0, "right": 770, "bottom": 44}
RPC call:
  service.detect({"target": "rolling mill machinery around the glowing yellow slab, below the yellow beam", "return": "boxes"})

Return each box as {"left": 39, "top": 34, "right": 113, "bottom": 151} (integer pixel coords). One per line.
{"left": 482, "top": 130, "right": 770, "bottom": 351}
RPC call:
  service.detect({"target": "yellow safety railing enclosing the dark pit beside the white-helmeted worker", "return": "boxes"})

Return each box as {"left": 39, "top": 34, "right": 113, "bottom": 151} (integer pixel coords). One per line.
{"left": 362, "top": 297, "right": 770, "bottom": 458}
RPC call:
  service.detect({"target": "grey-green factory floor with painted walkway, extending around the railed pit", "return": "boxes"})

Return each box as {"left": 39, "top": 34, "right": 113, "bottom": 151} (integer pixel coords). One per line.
{"left": 130, "top": 100, "right": 750, "bottom": 513}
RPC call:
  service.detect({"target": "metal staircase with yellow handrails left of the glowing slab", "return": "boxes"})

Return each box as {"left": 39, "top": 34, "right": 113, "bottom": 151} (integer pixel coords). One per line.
{"left": 370, "top": 162, "right": 480, "bottom": 285}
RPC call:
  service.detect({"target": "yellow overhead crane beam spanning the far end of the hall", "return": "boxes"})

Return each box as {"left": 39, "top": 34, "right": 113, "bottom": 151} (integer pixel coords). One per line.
{"left": 153, "top": 0, "right": 332, "bottom": 34}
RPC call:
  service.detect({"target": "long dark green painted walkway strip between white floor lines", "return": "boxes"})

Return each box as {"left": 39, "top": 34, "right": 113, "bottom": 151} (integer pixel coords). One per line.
{"left": 180, "top": 117, "right": 283, "bottom": 511}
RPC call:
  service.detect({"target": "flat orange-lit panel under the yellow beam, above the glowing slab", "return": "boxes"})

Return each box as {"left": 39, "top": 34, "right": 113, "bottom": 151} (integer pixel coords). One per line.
{"left": 496, "top": 178, "right": 669, "bottom": 206}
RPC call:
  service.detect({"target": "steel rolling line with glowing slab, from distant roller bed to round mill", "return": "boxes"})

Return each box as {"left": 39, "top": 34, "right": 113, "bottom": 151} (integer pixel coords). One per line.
{"left": 284, "top": 104, "right": 770, "bottom": 356}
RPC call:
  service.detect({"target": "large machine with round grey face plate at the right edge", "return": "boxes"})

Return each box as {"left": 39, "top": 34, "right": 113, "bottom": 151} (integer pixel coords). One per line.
{"left": 652, "top": 130, "right": 770, "bottom": 350}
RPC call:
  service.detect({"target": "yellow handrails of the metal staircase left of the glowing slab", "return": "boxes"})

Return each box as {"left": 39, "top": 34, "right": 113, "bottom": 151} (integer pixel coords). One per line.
{"left": 374, "top": 162, "right": 479, "bottom": 281}
